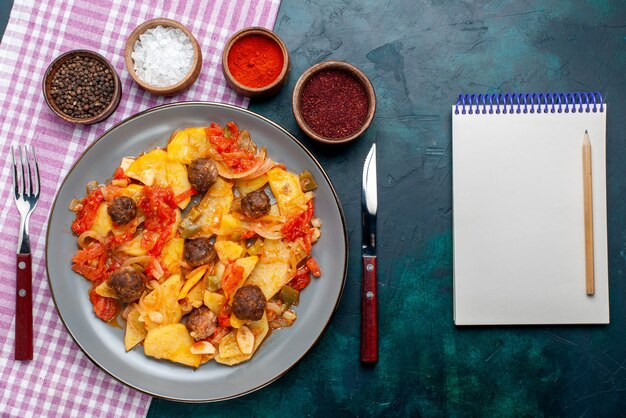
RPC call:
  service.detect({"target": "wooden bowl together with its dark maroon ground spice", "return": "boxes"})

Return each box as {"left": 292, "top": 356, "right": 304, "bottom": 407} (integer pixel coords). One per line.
{"left": 292, "top": 61, "right": 376, "bottom": 144}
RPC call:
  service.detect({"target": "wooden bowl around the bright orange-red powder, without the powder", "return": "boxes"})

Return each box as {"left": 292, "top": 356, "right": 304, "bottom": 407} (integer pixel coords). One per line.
{"left": 222, "top": 27, "right": 291, "bottom": 99}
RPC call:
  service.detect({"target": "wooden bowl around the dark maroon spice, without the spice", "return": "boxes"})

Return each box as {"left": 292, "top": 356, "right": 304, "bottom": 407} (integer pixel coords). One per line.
{"left": 291, "top": 61, "right": 376, "bottom": 144}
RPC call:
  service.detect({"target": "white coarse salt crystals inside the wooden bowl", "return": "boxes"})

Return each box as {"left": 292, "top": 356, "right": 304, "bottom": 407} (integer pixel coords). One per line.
{"left": 131, "top": 26, "right": 194, "bottom": 87}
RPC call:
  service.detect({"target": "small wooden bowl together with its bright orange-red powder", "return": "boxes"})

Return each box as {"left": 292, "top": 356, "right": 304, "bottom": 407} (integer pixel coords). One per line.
{"left": 222, "top": 27, "right": 290, "bottom": 98}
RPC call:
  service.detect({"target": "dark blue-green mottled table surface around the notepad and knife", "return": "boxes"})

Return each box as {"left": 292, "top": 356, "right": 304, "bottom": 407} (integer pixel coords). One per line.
{"left": 0, "top": 0, "right": 626, "bottom": 417}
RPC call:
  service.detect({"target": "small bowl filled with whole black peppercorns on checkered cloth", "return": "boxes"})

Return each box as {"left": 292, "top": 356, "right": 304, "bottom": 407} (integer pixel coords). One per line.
{"left": 42, "top": 49, "right": 122, "bottom": 125}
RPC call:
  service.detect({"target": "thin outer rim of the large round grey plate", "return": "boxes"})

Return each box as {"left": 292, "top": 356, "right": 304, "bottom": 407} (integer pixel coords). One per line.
{"left": 44, "top": 101, "right": 350, "bottom": 403}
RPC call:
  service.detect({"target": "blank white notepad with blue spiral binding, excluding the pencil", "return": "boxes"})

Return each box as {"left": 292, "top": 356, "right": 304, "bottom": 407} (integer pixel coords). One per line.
{"left": 452, "top": 93, "right": 609, "bottom": 325}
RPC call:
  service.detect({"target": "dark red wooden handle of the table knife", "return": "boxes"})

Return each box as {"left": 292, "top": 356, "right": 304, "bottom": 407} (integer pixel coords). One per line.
{"left": 361, "top": 256, "right": 378, "bottom": 363}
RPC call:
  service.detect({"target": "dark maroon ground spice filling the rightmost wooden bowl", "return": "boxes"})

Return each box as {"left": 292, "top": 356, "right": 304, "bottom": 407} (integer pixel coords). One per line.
{"left": 300, "top": 70, "right": 369, "bottom": 139}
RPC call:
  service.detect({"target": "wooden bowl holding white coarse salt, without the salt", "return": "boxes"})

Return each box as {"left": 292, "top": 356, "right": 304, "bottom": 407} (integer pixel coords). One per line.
{"left": 124, "top": 18, "right": 202, "bottom": 96}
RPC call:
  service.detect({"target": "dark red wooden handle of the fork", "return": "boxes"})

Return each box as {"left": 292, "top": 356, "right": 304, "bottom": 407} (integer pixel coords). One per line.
{"left": 15, "top": 254, "right": 33, "bottom": 360}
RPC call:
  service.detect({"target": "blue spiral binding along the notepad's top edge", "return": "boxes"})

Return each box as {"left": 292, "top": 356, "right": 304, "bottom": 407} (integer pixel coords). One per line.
{"left": 454, "top": 91, "right": 604, "bottom": 115}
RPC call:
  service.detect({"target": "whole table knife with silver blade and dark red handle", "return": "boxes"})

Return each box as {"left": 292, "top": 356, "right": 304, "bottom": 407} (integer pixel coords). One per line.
{"left": 361, "top": 144, "right": 378, "bottom": 363}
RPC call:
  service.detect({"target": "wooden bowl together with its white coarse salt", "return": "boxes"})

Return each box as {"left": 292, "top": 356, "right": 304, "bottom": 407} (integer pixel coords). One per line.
{"left": 124, "top": 18, "right": 202, "bottom": 96}
